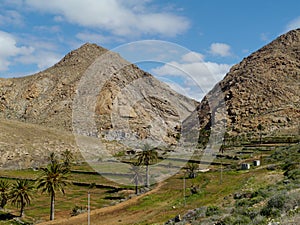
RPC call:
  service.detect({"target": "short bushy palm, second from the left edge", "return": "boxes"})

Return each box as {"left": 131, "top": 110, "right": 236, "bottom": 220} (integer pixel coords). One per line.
{"left": 10, "top": 179, "right": 34, "bottom": 217}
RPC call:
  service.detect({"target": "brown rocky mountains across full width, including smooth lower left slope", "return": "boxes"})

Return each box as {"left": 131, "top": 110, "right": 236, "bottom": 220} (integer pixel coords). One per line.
{"left": 0, "top": 29, "right": 300, "bottom": 170}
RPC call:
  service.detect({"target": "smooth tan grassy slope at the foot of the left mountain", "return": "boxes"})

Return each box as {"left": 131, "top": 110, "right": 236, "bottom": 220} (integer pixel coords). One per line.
{"left": 0, "top": 119, "right": 79, "bottom": 169}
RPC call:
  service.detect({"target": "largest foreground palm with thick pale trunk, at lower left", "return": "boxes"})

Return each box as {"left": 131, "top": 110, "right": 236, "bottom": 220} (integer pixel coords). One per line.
{"left": 37, "top": 160, "right": 69, "bottom": 220}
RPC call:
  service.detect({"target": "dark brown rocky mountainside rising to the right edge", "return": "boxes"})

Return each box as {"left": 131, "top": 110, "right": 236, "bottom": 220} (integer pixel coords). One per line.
{"left": 198, "top": 29, "right": 300, "bottom": 136}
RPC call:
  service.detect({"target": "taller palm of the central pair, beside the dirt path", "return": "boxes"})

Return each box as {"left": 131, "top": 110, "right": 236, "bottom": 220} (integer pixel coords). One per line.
{"left": 137, "top": 144, "right": 158, "bottom": 187}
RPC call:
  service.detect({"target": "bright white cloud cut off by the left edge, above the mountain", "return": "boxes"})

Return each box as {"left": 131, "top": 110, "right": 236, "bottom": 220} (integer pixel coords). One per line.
{"left": 0, "top": 31, "right": 34, "bottom": 71}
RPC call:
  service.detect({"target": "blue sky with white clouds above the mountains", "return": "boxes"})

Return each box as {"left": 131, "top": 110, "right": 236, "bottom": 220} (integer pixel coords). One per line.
{"left": 0, "top": 0, "right": 300, "bottom": 99}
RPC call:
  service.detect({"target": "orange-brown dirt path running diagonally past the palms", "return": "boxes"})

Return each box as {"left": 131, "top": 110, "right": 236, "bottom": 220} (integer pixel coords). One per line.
{"left": 39, "top": 182, "right": 163, "bottom": 225}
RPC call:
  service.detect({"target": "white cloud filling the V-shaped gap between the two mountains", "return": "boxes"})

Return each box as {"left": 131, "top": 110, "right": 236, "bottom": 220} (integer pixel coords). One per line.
{"left": 151, "top": 54, "right": 231, "bottom": 100}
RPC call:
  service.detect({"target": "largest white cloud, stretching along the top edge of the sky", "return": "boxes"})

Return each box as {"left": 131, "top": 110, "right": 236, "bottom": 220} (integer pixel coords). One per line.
{"left": 25, "top": 0, "right": 189, "bottom": 36}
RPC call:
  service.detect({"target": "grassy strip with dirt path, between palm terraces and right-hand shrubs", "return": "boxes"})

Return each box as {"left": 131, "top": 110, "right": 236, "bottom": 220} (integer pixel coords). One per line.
{"left": 36, "top": 170, "right": 282, "bottom": 225}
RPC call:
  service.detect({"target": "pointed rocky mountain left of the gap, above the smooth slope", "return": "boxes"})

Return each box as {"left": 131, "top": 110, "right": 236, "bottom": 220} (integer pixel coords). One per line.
{"left": 0, "top": 44, "right": 196, "bottom": 144}
